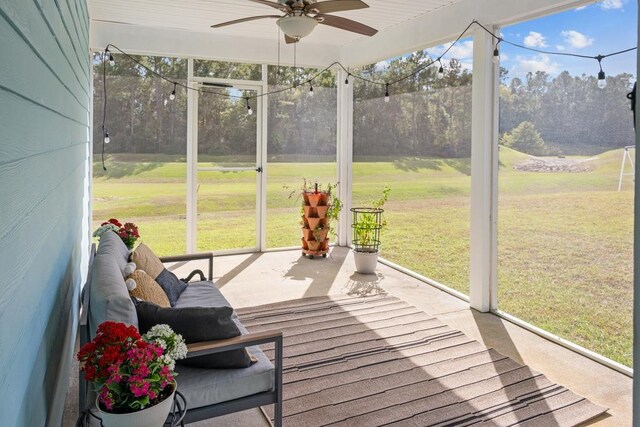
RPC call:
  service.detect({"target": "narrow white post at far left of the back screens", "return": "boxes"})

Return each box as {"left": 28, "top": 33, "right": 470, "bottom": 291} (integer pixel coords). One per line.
{"left": 187, "top": 59, "right": 198, "bottom": 253}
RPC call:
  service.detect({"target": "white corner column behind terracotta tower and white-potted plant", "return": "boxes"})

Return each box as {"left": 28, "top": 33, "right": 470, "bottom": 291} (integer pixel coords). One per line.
{"left": 337, "top": 68, "right": 354, "bottom": 246}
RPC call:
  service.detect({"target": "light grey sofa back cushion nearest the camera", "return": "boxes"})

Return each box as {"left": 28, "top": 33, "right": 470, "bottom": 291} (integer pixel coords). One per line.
{"left": 89, "top": 254, "right": 138, "bottom": 338}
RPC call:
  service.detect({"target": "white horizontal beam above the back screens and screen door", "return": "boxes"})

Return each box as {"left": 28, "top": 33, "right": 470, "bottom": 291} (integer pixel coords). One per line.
{"left": 90, "top": 21, "right": 340, "bottom": 68}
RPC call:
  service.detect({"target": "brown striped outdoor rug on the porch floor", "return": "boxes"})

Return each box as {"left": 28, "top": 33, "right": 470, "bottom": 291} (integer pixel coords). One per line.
{"left": 238, "top": 295, "right": 606, "bottom": 427}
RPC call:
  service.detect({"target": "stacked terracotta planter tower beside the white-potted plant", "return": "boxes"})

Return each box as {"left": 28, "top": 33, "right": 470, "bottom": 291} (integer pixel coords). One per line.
{"left": 302, "top": 187, "right": 329, "bottom": 258}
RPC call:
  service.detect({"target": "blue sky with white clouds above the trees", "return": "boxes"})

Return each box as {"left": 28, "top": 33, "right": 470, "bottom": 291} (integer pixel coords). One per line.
{"left": 420, "top": 0, "right": 638, "bottom": 78}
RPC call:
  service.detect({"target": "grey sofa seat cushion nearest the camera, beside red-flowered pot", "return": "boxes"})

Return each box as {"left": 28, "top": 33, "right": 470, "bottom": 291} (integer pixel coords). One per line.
{"left": 176, "top": 346, "right": 275, "bottom": 409}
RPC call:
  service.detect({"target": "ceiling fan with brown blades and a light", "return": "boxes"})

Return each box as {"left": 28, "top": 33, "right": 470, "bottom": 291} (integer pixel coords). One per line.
{"left": 211, "top": 0, "right": 378, "bottom": 43}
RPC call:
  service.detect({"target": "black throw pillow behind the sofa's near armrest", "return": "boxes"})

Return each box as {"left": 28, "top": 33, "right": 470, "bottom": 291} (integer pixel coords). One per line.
{"left": 136, "top": 301, "right": 255, "bottom": 369}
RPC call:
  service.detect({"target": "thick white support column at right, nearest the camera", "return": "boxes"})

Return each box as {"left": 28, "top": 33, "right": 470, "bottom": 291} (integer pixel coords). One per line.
{"left": 469, "top": 29, "right": 498, "bottom": 312}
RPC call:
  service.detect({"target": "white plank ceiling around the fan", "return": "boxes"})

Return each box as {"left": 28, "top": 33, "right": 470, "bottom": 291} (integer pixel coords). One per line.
{"left": 89, "top": 0, "right": 461, "bottom": 46}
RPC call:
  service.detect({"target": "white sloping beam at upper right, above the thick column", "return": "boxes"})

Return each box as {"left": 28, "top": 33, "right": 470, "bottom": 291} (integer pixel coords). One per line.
{"left": 340, "top": 0, "right": 593, "bottom": 67}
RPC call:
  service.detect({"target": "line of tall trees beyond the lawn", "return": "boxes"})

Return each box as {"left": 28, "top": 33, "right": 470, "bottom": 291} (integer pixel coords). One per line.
{"left": 94, "top": 51, "right": 633, "bottom": 160}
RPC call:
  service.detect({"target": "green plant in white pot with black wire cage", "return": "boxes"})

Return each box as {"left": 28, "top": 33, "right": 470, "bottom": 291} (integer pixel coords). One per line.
{"left": 351, "top": 185, "right": 391, "bottom": 274}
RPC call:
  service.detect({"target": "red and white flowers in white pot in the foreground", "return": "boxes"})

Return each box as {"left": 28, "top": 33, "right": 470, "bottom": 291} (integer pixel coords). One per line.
{"left": 78, "top": 321, "right": 187, "bottom": 427}
